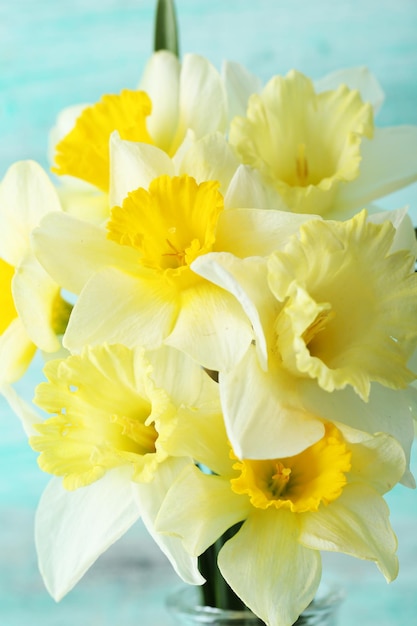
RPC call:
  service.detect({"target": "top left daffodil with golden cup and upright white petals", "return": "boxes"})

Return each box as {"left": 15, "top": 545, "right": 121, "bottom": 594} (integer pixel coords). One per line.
{"left": 53, "top": 51, "right": 227, "bottom": 192}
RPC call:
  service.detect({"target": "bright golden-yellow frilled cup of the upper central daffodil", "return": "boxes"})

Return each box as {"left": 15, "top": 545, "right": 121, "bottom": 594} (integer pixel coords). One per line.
{"left": 107, "top": 175, "right": 223, "bottom": 275}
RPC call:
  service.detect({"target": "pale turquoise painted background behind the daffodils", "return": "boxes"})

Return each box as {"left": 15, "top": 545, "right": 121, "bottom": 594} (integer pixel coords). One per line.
{"left": 0, "top": 0, "right": 417, "bottom": 626}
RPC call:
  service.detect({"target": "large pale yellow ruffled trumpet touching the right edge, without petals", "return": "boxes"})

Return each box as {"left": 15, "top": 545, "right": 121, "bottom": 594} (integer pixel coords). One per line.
{"left": 268, "top": 212, "right": 417, "bottom": 401}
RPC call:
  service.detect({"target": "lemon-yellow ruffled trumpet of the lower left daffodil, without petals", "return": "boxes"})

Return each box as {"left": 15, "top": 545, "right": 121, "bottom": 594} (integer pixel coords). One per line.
{"left": 30, "top": 345, "right": 173, "bottom": 490}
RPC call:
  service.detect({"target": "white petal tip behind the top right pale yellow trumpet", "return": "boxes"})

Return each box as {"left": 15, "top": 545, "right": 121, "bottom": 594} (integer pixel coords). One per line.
{"left": 314, "top": 67, "right": 385, "bottom": 113}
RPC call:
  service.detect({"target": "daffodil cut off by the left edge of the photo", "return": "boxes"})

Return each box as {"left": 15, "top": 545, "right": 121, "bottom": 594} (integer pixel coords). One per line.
{"left": 0, "top": 161, "right": 71, "bottom": 384}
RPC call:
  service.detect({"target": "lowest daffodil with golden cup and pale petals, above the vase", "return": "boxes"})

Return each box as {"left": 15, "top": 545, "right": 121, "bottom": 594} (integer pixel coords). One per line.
{"left": 156, "top": 422, "right": 405, "bottom": 626}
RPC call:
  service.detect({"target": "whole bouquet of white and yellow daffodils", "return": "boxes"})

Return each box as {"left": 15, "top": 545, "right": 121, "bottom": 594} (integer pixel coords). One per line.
{"left": 0, "top": 1, "right": 417, "bottom": 626}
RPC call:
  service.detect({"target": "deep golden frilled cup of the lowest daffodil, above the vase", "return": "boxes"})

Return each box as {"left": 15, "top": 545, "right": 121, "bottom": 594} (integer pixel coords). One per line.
{"left": 231, "top": 422, "right": 351, "bottom": 513}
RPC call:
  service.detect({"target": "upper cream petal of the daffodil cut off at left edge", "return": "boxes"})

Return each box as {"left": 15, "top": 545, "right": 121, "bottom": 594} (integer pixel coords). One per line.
{"left": 0, "top": 161, "right": 61, "bottom": 266}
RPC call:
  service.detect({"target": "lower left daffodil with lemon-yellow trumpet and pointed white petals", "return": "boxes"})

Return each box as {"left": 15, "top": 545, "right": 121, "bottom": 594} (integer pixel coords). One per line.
{"left": 15, "top": 345, "right": 218, "bottom": 600}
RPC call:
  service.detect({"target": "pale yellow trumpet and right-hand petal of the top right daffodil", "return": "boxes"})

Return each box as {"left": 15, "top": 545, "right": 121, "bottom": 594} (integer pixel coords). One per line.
{"left": 230, "top": 71, "right": 417, "bottom": 217}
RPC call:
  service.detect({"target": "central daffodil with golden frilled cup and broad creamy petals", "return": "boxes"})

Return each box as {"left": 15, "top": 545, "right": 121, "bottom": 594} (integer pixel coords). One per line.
{"left": 34, "top": 175, "right": 309, "bottom": 369}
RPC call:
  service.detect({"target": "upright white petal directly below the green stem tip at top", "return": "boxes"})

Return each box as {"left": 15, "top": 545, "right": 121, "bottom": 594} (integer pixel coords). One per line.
{"left": 139, "top": 50, "right": 181, "bottom": 151}
